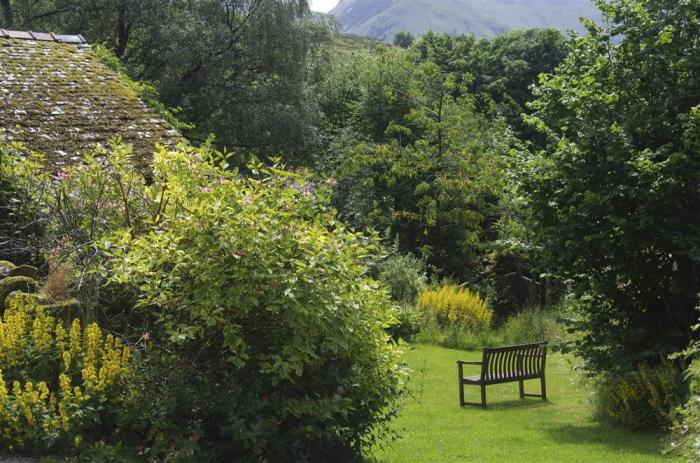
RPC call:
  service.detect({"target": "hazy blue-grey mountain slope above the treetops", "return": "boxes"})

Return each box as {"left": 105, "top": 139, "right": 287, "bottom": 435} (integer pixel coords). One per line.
{"left": 331, "top": 0, "right": 600, "bottom": 41}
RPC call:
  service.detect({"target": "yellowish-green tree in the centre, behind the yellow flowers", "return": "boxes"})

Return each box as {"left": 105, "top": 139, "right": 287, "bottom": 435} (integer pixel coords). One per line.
{"left": 335, "top": 55, "right": 513, "bottom": 279}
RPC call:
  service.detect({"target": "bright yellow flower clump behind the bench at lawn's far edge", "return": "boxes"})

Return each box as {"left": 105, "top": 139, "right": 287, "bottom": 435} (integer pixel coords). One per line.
{"left": 418, "top": 284, "right": 493, "bottom": 329}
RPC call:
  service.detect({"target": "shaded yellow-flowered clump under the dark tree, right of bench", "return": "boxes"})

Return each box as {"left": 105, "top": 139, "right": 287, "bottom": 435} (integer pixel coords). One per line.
{"left": 597, "top": 363, "right": 687, "bottom": 429}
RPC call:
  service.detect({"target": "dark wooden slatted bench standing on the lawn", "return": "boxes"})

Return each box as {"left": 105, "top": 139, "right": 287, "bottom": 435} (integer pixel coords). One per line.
{"left": 457, "top": 342, "right": 547, "bottom": 407}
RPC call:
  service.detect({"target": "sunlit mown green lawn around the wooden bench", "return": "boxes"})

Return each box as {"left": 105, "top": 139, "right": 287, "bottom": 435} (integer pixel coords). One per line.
{"left": 375, "top": 345, "right": 671, "bottom": 463}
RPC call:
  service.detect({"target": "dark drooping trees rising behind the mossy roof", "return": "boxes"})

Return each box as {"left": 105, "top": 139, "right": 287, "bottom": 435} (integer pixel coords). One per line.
{"left": 9, "top": 0, "right": 330, "bottom": 162}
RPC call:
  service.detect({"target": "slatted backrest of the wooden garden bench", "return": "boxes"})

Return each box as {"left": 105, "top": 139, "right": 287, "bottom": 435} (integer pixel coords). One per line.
{"left": 481, "top": 342, "right": 547, "bottom": 381}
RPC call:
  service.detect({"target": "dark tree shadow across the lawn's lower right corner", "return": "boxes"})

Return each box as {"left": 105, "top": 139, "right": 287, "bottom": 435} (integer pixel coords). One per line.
{"left": 544, "top": 423, "right": 663, "bottom": 455}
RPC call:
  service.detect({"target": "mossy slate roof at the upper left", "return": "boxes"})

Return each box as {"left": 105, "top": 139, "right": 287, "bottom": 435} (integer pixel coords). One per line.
{"left": 0, "top": 30, "right": 183, "bottom": 167}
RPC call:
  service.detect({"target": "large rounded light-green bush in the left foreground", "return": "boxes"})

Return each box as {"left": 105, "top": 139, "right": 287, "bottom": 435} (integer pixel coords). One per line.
{"left": 107, "top": 151, "right": 404, "bottom": 461}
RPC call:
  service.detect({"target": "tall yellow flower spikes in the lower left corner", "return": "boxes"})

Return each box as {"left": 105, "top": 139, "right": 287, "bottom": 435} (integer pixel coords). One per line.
{"left": 0, "top": 294, "right": 131, "bottom": 453}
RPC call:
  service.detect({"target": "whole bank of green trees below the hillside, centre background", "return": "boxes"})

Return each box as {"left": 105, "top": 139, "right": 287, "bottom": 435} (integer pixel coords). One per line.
{"left": 318, "top": 31, "right": 567, "bottom": 282}
